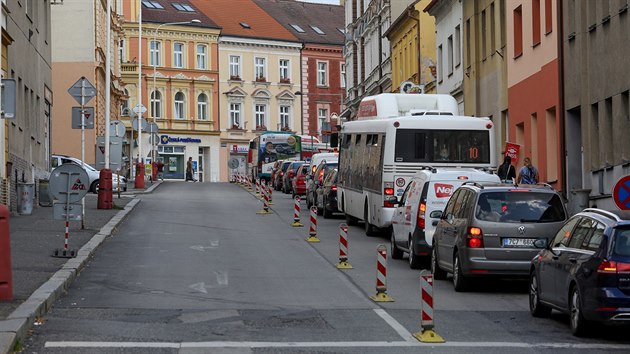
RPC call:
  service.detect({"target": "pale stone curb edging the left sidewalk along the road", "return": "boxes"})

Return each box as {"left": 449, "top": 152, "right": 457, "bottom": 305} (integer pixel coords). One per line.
{"left": 0, "top": 198, "right": 143, "bottom": 354}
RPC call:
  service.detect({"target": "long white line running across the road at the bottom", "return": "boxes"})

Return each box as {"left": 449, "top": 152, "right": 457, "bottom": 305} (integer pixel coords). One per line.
{"left": 44, "top": 341, "right": 630, "bottom": 350}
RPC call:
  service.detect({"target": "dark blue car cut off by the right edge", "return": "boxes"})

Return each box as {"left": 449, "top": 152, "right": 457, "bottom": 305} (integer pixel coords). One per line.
{"left": 529, "top": 208, "right": 630, "bottom": 336}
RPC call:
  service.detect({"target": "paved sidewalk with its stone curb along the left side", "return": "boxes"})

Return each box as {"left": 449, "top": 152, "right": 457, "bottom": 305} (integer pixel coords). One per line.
{"left": 0, "top": 182, "right": 160, "bottom": 354}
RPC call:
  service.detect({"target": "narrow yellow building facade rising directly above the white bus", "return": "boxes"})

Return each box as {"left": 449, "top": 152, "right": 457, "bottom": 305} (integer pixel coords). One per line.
{"left": 385, "top": 0, "right": 436, "bottom": 93}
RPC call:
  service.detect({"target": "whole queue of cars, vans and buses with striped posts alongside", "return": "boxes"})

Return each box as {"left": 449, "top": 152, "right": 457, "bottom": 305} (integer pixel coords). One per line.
{"left": 243, "top": 94, "right": 630, "bottom": 342}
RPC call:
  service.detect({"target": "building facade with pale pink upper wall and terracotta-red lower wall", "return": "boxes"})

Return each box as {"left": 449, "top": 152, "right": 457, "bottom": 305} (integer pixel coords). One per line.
{"left": 505, "top": 0, "right": 565, "bottom": 194}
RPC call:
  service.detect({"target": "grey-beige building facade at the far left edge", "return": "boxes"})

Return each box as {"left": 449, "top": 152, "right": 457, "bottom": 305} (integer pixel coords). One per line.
{"left": 0, "top": 0, "right": 53, "bottom": 212}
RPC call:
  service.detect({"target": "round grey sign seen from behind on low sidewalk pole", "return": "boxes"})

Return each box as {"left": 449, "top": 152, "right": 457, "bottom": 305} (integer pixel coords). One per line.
{"left": 48, "top": 163, "right": 90, "bottom": 203}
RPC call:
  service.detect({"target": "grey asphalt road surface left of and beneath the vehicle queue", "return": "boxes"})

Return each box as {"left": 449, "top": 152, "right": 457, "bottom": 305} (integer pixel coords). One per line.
{"left": 19, "top": 182, "right": 630, "bottom": 353}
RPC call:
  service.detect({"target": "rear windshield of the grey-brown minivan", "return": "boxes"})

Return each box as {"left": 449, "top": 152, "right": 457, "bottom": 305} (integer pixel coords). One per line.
{"left": 475, "top": 191, "right": 566, "bottom": 223}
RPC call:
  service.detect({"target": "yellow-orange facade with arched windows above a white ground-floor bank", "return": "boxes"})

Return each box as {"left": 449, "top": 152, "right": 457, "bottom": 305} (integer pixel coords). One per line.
{"left": 120, "top": 0, "right": 223, "bottom": 182}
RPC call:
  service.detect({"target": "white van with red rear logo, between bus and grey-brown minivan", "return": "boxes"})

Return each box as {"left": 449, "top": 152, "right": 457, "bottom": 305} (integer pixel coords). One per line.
{"left": 391, "top": 167, "right": 501, "bottom": 269}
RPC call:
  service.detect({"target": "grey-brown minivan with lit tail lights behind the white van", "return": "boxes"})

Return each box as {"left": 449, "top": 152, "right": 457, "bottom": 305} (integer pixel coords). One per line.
{"left": 431, "top": 182, "right": 567, "bottom": 291}
